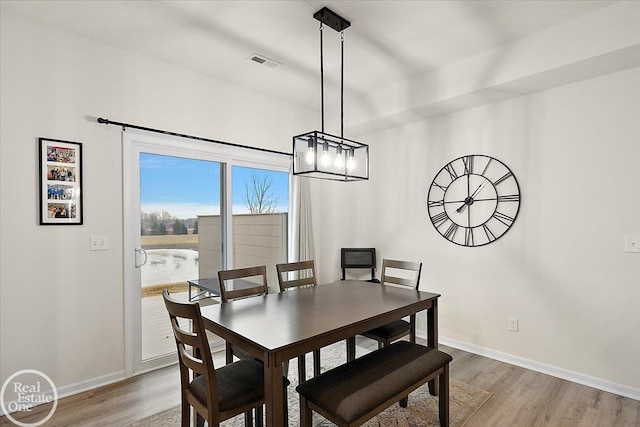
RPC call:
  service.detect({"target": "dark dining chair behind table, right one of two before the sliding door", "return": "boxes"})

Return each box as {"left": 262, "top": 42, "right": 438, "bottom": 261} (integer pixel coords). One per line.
{"left": 276, "top": 260, "right": 320, "bottom": 383}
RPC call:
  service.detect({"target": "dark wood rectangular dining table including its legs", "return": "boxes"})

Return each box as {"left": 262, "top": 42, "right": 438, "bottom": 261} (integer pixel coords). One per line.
{"left": 201, "top": 280, "right": 440, "bottom": 427}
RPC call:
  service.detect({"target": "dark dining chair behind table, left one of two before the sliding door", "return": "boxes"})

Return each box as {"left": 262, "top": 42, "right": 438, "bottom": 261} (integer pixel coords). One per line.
{"left": 218, "top": 265, "right": 269, "bottom": 363}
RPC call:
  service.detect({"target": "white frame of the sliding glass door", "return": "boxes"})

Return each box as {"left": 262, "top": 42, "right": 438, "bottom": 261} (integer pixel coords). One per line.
{"left": 122, "top": 129, "right": 292, "bottom": 377}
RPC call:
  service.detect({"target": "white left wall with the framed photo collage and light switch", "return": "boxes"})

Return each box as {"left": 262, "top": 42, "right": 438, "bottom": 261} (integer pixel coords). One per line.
{"left": 0, "top": 13, "right": 317, "bottom": 392}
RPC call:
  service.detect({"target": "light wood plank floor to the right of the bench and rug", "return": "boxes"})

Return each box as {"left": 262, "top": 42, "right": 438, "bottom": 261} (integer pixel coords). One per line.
{"left": 448, "top": 346, "right": 640, "bottom": 427}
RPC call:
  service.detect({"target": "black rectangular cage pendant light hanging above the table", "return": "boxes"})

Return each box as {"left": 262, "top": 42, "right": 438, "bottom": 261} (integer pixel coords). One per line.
{"left": 293, "top": 7, "right": 369, "bottom": 181}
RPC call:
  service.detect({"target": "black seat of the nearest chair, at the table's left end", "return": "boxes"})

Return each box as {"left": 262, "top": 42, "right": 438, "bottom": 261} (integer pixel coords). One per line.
{"left": 189, "top": 360, "right": 264, "bottom": 412}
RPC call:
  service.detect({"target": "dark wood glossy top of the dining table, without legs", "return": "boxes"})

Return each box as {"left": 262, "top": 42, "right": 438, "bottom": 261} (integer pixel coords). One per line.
{"left": 201, "top": 280, "right": 440, "bottom": 358}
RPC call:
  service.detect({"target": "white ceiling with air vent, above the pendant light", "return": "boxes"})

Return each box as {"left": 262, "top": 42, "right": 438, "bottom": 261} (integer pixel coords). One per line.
{"left": 0, "top": 0, "right": 617, "bottom": 113}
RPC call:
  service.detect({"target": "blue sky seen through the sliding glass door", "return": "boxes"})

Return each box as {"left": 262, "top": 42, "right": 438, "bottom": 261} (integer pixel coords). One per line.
{"left": 140, "top": 153, "right": 289, "bottom": 219}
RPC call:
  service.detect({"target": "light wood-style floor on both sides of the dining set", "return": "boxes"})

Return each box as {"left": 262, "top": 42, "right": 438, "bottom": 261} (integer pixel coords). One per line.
{"left": 0, "top": 338, "right": 640, "bottom": 427}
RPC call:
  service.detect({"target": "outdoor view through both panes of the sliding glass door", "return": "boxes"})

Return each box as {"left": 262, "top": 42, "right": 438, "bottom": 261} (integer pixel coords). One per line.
{"left": 140, "top": 153, "right": 289, "bottom": 360}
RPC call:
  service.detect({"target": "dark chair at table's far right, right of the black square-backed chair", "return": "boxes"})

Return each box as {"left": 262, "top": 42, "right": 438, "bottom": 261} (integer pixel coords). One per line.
{"left": 362, "top": 259, "right": 422, "bottom": 349}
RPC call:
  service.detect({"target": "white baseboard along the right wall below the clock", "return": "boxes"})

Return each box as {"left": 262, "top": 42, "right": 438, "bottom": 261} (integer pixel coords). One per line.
{"left": 438, "top": 331, "right": 640, "bottom": 400}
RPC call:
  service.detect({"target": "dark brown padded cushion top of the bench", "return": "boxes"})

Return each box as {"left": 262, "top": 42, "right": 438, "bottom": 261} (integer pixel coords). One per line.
{"left": 296, "top": 341, "right": 452, "bottom": 423}
